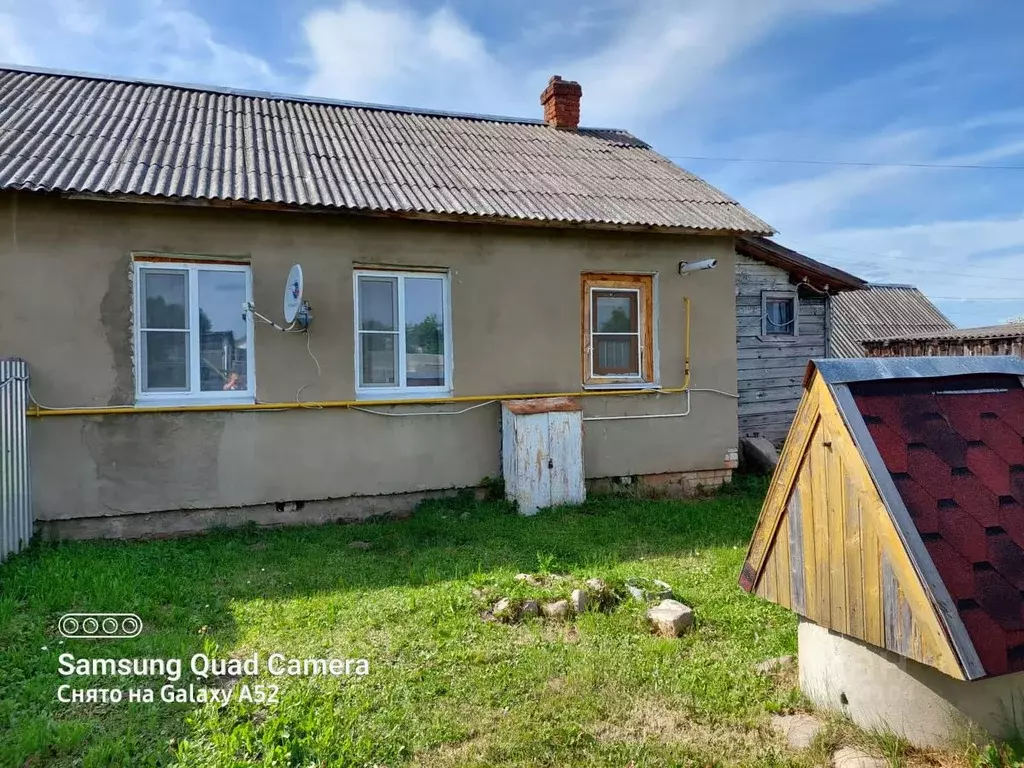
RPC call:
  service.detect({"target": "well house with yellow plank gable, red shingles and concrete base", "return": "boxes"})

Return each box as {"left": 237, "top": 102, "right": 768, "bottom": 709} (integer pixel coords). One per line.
{"left": 740, "top": 356, "right": 1024, "bottom": 744}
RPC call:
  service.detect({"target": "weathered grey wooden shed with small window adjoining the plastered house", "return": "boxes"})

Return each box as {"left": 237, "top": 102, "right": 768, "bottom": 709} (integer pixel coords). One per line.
{"left": 736, "top": 237, "right": 865, "bottom": 444}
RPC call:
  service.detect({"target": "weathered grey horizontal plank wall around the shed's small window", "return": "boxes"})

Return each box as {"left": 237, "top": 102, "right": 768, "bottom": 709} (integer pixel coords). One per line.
{"left": 736, "top": 254, "right": 826, "bottom": 444}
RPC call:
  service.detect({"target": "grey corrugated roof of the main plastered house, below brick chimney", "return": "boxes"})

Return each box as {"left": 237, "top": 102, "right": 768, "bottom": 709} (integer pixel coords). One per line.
{"left": 0, "top": 69, "right": 772, "bottom": 234}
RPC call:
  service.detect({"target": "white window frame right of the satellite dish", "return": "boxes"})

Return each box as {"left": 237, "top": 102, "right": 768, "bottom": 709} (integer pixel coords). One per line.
{"left": 352, "top": 266, "right": 455, "bottom": 400}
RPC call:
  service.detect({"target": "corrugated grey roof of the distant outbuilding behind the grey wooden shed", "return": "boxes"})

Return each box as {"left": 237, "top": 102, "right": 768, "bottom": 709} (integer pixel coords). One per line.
{"left": 830, "top": 285, "right": 955, "bottom": 357}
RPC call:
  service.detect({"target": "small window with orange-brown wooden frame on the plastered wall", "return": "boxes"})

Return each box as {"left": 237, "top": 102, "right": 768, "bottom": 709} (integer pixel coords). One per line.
{"left": 581, "top": 273, "right": 654, "bottom": 386}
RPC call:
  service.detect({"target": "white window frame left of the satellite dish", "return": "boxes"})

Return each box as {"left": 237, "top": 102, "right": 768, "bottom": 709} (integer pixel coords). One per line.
{"left": 132, "top": 256, "right": 256, "bottom": 406}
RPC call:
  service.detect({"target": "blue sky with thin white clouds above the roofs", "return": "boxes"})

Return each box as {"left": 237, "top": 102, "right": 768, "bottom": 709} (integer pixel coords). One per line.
{"left": 0, "top": 0, "right": 1024, "bottom": 326}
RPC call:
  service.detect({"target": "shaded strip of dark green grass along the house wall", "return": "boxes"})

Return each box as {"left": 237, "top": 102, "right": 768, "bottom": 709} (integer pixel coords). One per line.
{"left": 0, "top": 481, "right": 764, "bottom": 765}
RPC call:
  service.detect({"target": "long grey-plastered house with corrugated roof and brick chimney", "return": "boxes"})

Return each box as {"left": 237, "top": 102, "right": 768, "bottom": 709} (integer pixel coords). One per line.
{"left": 0, "top": 69, "right": 771, "bottom": 537}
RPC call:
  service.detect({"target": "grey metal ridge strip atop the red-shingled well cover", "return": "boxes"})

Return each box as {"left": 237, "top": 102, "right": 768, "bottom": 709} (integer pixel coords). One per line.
{"left": 810, "top": 357, "right": 1024, "bottom": 384}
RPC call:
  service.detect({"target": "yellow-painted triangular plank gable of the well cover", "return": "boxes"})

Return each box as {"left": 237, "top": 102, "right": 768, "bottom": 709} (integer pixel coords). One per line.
{"left": 744, "top": 375, "right": 965, "bottom": 679}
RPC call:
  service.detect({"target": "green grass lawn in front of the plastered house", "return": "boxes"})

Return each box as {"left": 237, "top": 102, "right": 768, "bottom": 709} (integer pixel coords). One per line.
{"left": 0, "top": 485, "right": 807, "bottom": 768}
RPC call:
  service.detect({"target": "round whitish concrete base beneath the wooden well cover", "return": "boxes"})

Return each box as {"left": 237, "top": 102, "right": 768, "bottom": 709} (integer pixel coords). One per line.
{"left": 799, "top": 620, "right": 1024, "bottom": 746}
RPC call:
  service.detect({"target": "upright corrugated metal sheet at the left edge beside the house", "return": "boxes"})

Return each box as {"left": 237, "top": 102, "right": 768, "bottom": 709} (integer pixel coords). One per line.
{"left": 0, "top": 357, "right": 32, "bottom": 562}
